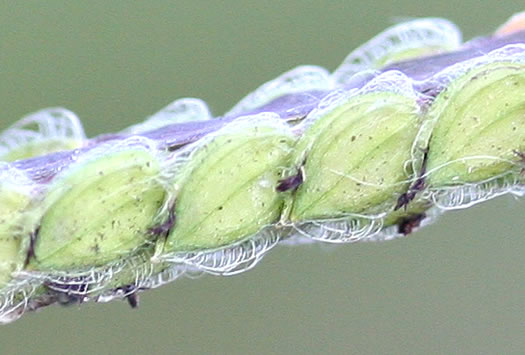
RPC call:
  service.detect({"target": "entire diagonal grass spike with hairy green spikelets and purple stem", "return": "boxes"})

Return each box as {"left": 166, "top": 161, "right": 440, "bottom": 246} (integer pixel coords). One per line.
{"left": 0, "top": 15, "right": 525, "bottom": 322}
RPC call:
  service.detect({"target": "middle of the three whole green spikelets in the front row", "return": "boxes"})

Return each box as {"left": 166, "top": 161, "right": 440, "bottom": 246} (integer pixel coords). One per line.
{"left": 166, "top": 119, "right": 293, "bottom": 251}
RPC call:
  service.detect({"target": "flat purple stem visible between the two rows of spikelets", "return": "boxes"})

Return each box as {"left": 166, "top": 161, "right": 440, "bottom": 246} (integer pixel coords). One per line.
{"left": 12, "top": 30, "right": 525, "bottom": 183}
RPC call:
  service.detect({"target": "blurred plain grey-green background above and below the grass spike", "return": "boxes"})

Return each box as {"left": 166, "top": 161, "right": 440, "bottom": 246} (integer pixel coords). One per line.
{"left": 0, "top": 0, "right": 525, "bottom": 354}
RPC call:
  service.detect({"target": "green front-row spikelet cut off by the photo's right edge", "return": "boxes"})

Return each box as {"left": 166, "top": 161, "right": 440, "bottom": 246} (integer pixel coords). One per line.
{"left": 427, "top": 62, "right": 525, "bottom": 188}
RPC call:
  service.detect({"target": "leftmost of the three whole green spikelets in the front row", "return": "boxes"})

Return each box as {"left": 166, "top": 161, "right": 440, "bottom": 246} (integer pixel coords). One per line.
{"left": 30, "top": 148, "right": 165, "bottom": 270}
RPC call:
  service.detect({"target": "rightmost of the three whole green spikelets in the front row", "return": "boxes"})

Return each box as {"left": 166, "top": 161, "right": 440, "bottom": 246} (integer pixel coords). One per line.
{"left": 291, "top": 92, "right": 420, "bottom": 222}
